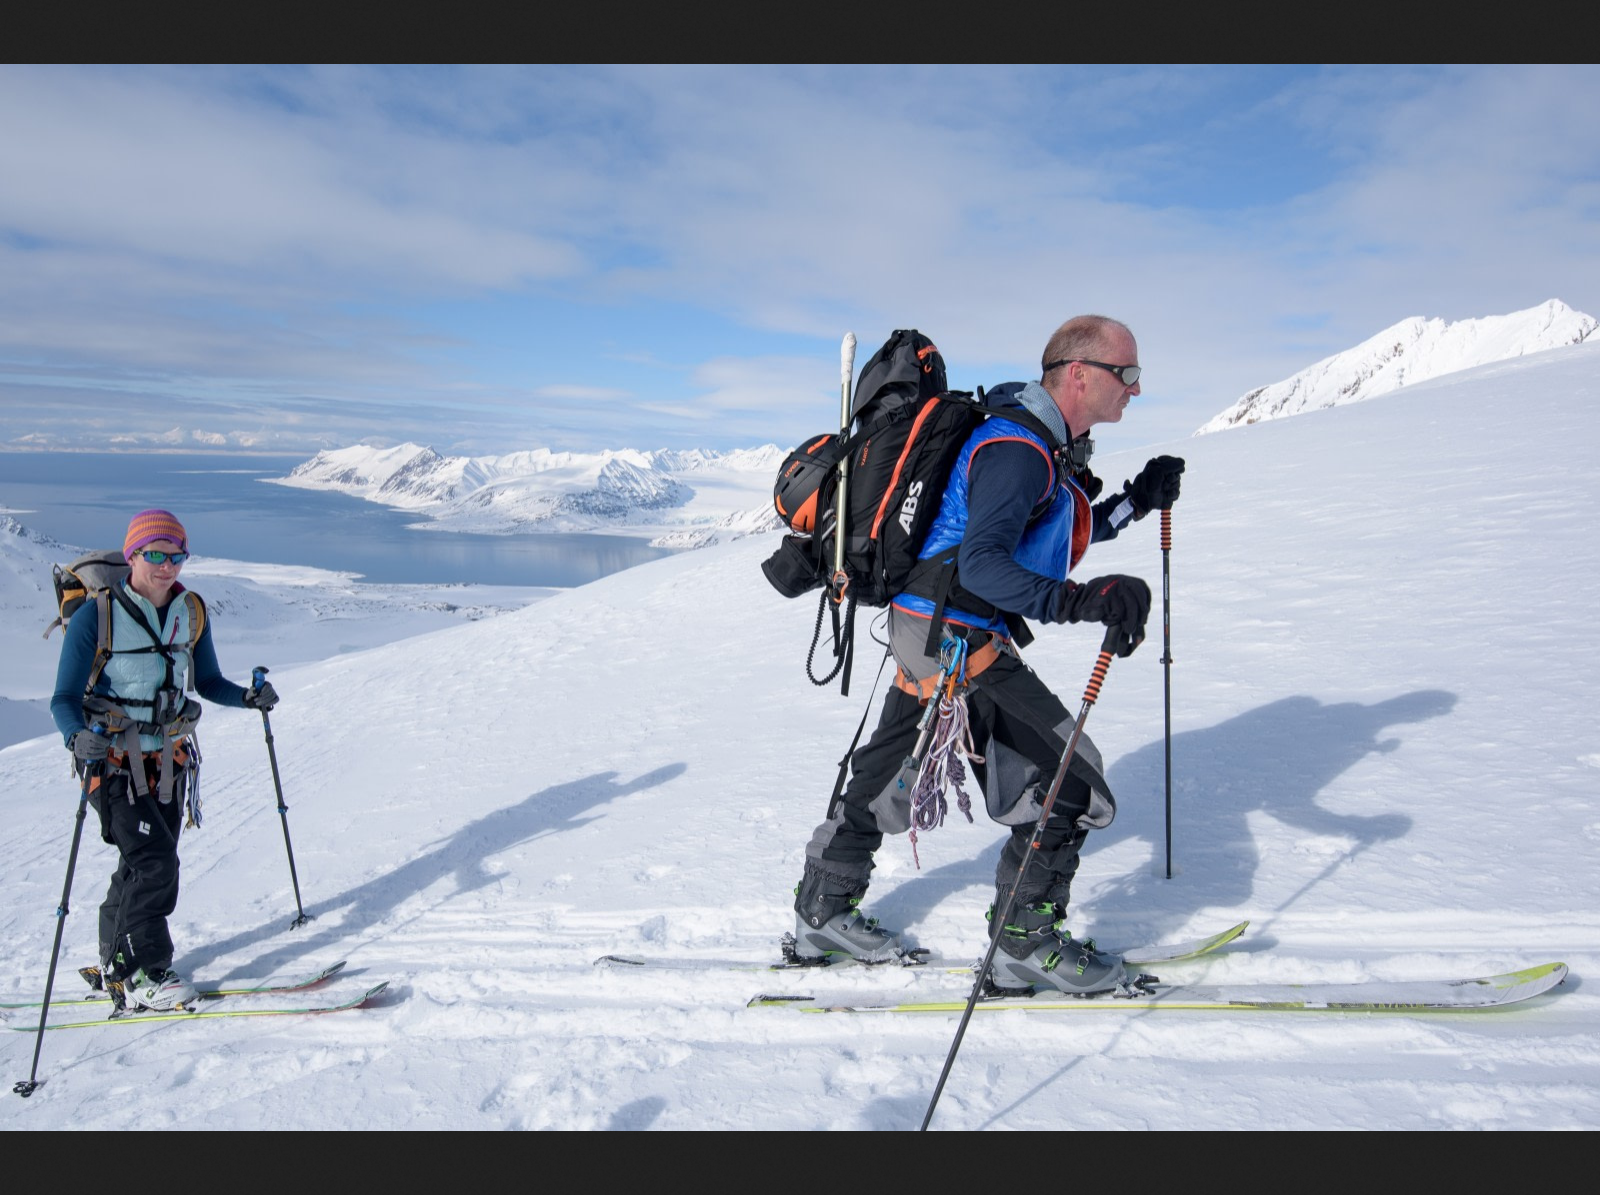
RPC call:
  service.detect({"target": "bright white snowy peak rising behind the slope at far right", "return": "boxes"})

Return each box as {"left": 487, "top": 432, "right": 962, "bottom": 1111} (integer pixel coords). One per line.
{"left": 1195, "top": 299, "right": 1600, "bottom": 435}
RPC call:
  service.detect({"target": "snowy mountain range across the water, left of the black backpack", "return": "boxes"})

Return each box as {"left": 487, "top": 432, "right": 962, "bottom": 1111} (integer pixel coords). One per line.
{"left": 282, "top": 443, "right": 784, "bottom": 547}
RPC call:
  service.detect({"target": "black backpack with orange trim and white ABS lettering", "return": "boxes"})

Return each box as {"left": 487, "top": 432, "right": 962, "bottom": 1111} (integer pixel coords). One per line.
{"left": 762, "top": 330, "right": 1062, "bottom": 694}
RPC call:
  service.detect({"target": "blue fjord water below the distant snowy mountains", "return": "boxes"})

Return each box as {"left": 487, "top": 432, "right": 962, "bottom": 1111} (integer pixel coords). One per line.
{"left": 0, "top": 453, "right": 667, "bottom": 587}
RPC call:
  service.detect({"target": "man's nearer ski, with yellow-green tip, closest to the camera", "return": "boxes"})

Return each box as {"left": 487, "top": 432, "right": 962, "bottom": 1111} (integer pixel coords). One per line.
{"left": 749, "top": 963, "right": 1566, "bottom": 1013}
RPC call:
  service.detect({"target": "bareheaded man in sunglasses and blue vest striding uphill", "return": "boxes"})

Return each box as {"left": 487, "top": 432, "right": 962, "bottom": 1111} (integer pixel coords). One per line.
{"left": 795, "top": 315, "right": 1184, "bottom": 992}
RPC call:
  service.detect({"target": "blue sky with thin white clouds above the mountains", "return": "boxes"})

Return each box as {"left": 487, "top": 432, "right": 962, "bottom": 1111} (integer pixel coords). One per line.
{"left": 0, "top": 66, "right": 1600, "bottom": 454}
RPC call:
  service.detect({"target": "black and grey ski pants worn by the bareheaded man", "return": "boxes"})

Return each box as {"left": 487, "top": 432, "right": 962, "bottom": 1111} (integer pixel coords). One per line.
{"left": 802, "top": 654, "right": 1104, "bottom": 909}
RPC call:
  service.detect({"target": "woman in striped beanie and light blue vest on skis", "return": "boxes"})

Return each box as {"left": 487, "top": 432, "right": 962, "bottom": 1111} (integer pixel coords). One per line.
{"left": 50, "top": 510, "right": 278, "bottom": 1009}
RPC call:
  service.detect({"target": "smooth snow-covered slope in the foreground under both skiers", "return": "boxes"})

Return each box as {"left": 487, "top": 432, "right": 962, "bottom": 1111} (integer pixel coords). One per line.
{"left": 0, "top": 344, "right": 1600, "bottom": 1129}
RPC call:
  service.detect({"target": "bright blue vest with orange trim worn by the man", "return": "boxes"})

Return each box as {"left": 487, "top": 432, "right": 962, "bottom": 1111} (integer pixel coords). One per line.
{"left": 893, "top": 414, "right": 1094, "bottom": 635}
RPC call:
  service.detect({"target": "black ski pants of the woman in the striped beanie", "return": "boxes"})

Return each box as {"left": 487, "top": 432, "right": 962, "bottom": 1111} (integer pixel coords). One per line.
{"left": 90, "top": 765, "right": 184, "bottom": 977}
